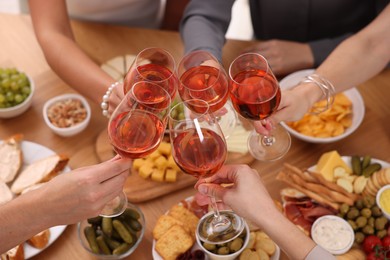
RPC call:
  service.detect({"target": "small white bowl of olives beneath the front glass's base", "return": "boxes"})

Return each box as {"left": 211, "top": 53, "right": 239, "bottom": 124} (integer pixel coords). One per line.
{"left": 196, "top": 219, "right": 250, "bottom": 260}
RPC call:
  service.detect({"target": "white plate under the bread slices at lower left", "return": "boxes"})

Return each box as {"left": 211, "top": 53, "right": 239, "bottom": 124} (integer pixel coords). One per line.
{"left": 5, "top": 141, "right": 71, "bottom": 259}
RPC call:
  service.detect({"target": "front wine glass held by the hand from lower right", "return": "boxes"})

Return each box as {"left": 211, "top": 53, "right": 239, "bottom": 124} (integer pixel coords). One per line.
{"left": 168, "top": 99, "right": 245, "bottom": 244}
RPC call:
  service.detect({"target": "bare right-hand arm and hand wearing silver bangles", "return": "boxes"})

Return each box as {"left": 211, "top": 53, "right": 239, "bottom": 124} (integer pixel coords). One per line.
{"left": 255, "top": 4, "right": 390, "bottom": 134}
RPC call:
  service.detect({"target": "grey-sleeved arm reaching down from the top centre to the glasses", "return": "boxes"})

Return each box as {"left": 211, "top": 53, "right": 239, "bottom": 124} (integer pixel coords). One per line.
{"left": 180, "top": 0, "right": 234, "bottom": 61}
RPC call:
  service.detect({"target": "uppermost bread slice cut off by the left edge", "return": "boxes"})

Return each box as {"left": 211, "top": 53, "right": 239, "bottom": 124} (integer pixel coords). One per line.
{"left": 0, "top": 134, "right": 23, "bottom": 183}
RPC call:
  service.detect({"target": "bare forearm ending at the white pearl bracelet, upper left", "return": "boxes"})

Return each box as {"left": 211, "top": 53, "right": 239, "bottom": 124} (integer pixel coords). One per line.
{"left": 40, "top": 34, "right": 115, "bottom": 104}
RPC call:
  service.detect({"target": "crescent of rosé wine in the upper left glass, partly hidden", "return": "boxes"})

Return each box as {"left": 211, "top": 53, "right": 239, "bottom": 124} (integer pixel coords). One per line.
{"left": 123, "top": 64, "right": 178, "bottom": 99}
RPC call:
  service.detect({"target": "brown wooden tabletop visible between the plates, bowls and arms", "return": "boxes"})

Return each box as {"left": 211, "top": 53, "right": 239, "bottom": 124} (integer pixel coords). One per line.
{"left": 0, "top": 14, "right": 390, "bottom": 260}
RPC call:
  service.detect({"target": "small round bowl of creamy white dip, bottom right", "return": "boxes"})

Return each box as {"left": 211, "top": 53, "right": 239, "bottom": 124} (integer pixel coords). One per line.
{"left": 311, "top": 215, "right": 355, "bottom": 255}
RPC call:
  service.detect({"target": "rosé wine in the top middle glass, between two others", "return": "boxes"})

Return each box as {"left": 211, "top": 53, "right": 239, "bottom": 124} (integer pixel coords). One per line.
{"left": 178, "top": 66, "right": 229, "bottom": 112}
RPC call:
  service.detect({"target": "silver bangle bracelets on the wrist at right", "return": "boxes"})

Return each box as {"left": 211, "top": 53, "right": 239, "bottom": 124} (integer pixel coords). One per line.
{"left": 300, "top": 74, "right": 335, "bottom": 114}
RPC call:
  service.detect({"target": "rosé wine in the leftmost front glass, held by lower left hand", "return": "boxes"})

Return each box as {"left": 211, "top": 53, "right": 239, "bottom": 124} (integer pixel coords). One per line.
{"left": 108, "top": 110, "right": 165, "bottom": 159}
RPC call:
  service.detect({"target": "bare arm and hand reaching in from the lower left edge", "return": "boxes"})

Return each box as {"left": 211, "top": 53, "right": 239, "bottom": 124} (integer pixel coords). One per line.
{"left": 0, "top": 157, "right": 131, "bottom": 254}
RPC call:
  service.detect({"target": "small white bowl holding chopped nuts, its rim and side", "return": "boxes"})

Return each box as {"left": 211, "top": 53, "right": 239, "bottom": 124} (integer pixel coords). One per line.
{"left": 42, "top": 94, "right": 91, "bottom": 137}
